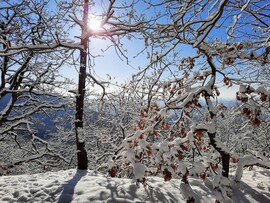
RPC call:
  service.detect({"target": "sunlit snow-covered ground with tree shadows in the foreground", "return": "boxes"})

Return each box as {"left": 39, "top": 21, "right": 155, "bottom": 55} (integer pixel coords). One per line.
{"left": 0, "top": 168, "right": 270, "bottom": 203}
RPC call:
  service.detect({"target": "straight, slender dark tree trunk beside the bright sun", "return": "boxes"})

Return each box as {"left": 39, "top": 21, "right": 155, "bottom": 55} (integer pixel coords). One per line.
{"left": 75, "top": 0, "right": 89, "bottom": 170}
